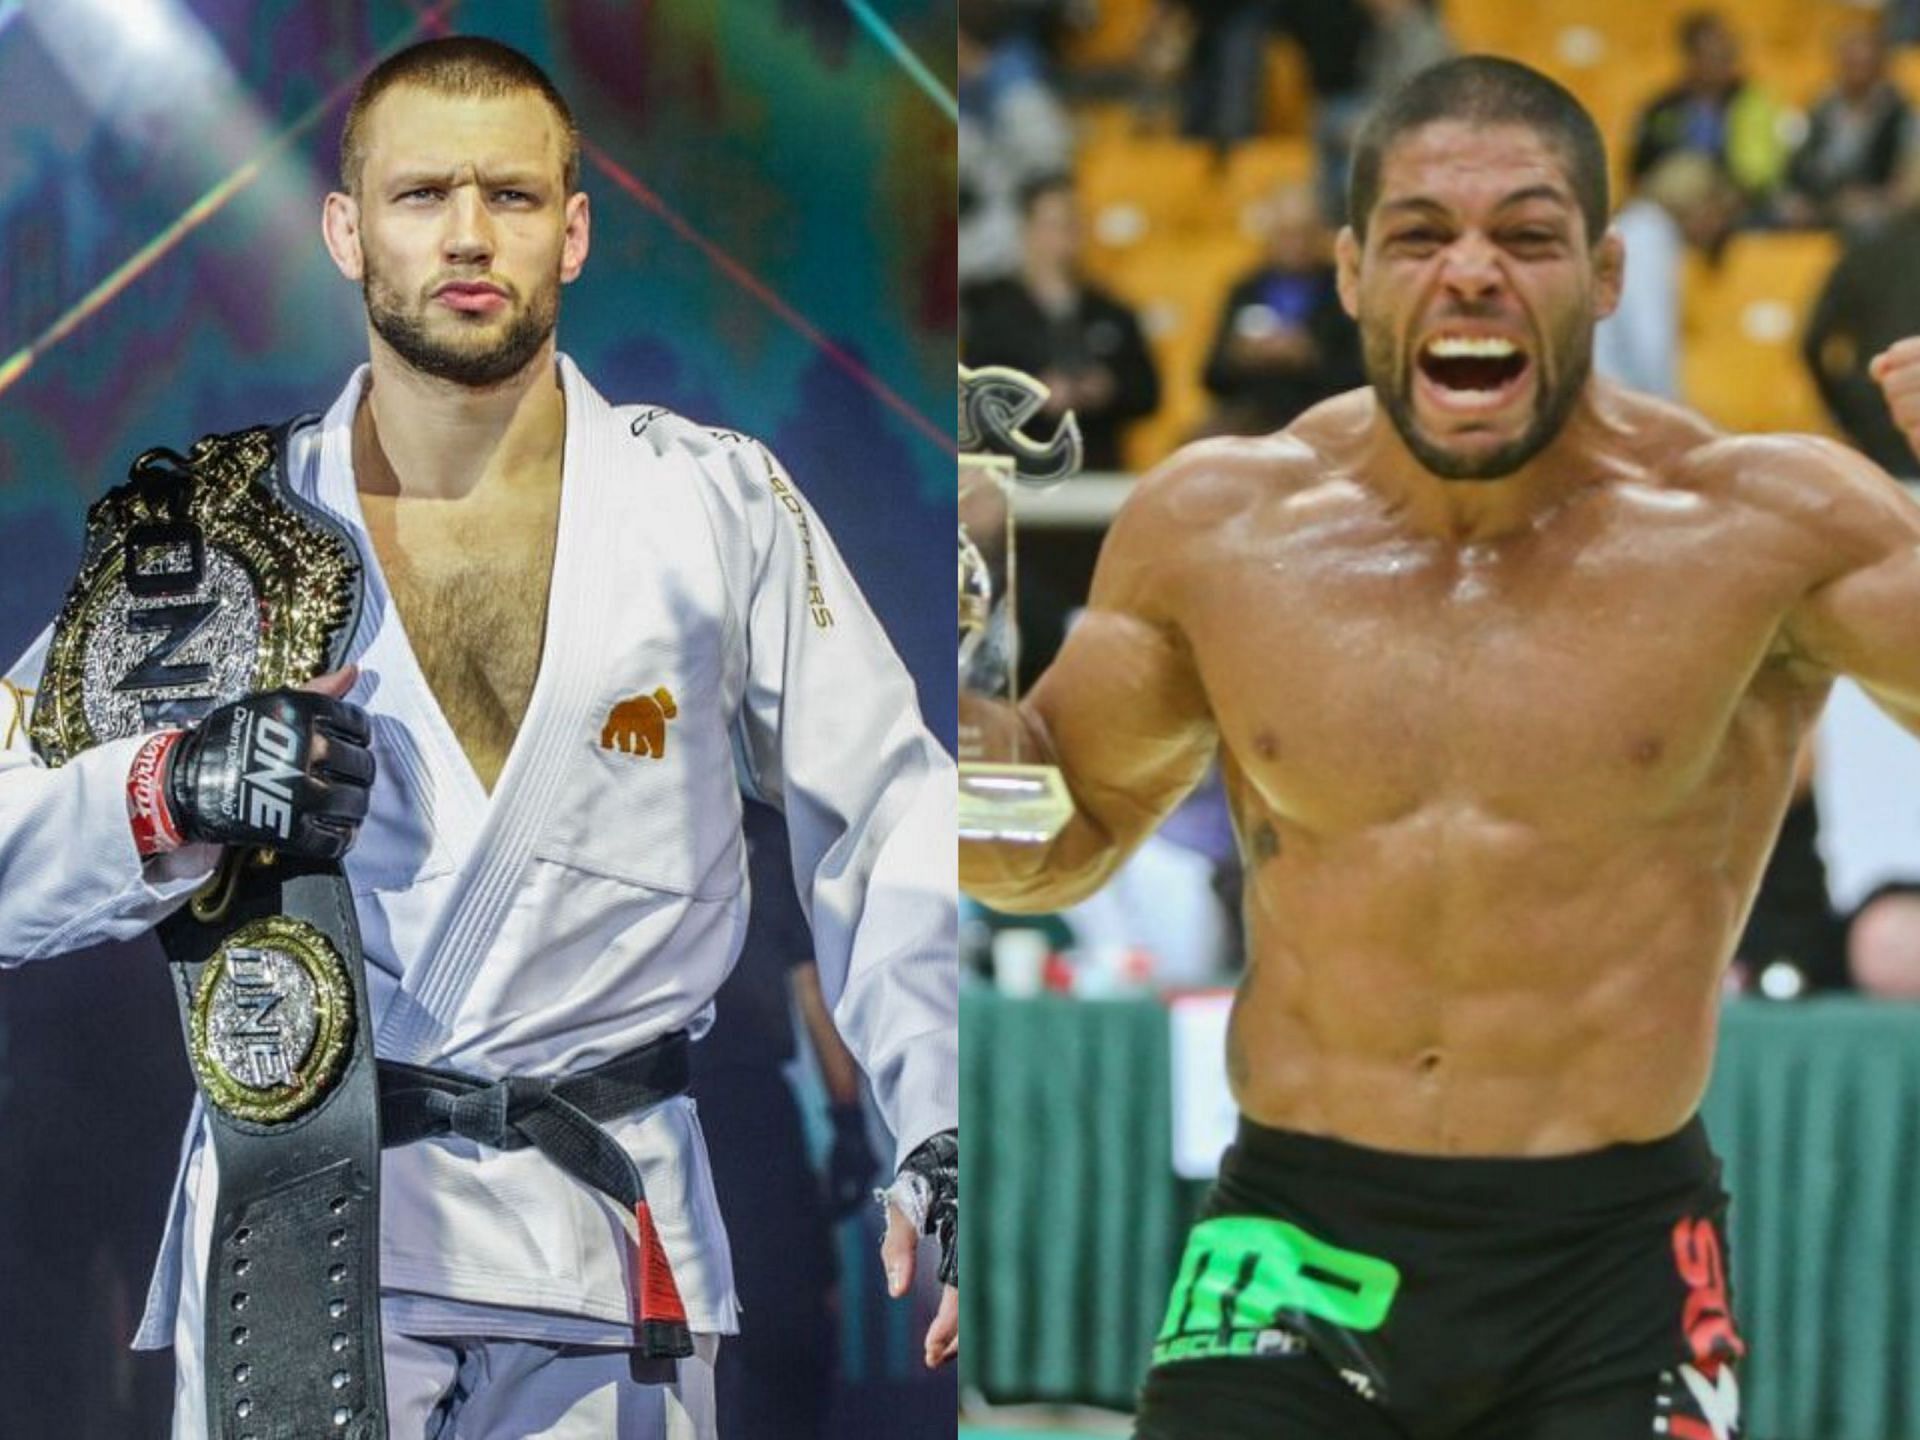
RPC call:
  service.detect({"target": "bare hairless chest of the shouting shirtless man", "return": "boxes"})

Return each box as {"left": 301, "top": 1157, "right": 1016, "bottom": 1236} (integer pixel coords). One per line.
{"left": 1190, "top": 499, "right": 1791, "bottom": 824}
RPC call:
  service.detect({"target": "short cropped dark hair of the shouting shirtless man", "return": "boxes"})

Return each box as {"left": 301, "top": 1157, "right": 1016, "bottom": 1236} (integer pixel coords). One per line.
{"left": 1346, "top": 56, "right": 1611, "bottom": 242}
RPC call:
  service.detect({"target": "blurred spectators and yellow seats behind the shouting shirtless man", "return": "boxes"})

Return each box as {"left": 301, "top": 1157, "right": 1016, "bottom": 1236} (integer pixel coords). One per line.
{"left": 958, "top": 0, "right": 1920, "bottom": 998}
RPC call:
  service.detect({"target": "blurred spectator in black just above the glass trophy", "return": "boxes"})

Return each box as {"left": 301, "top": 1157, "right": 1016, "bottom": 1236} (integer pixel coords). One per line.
{"left": 960, "top": 177, "right": 1160, "bottom": 470}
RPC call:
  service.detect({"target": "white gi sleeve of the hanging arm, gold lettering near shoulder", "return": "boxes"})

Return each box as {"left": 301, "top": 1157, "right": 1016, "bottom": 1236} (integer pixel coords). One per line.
{"left": 735, "top": 445, "right": 960, "bottom": 1162}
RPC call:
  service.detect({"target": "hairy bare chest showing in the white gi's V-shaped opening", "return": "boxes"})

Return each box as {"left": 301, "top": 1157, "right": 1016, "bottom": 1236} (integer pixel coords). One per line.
{"left": 367, "top": 488, "right": 559, "bottom": 789}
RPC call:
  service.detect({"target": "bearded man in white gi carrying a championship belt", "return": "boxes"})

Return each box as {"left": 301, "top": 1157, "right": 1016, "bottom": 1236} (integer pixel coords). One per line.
{"left": 0, "top": 38, "right": 958, "bottom": 1440}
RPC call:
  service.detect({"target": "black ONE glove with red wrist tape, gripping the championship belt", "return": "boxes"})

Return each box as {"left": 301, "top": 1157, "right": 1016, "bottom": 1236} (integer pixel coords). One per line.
{"left": 127, "top": 689, "right": 374, "bottom": 860}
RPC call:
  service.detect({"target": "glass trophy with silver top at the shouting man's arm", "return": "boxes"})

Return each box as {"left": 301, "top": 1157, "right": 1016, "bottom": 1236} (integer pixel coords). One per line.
{"left": 960, "top": 365, "right": 1081, "bottom": 845}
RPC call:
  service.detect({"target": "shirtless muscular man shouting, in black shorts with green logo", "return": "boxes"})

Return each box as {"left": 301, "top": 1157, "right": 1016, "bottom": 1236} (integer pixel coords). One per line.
{"left": 962, "top": 58, "right": 1920, "bottom": 1440}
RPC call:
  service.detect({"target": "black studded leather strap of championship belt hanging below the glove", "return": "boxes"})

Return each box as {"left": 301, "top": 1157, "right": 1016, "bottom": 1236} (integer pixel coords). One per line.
{"left": 159, "top": 862, "right": 388, "bottom": 1440}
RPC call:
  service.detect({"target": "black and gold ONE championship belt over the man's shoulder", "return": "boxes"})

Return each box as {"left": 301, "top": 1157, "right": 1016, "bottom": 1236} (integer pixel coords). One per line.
{"left": 33, "top": 420, "right": 386, "bottom": 1440}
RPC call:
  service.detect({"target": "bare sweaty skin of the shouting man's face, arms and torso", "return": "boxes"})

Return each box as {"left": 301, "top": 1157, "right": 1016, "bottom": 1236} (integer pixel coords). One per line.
{"left": 962, "top": 123, "right": 1920, "bottom": 1156}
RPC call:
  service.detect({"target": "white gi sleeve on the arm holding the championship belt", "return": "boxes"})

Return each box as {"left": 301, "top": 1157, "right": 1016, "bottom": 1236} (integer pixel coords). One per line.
{"left": 0, "top": 628, "right": 219, "bottom": 966}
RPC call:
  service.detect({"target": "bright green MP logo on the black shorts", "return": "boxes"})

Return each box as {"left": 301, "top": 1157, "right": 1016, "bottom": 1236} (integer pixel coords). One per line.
{"left": 1154, "top": 1215, "right": 1400, "bottom": 1363}
